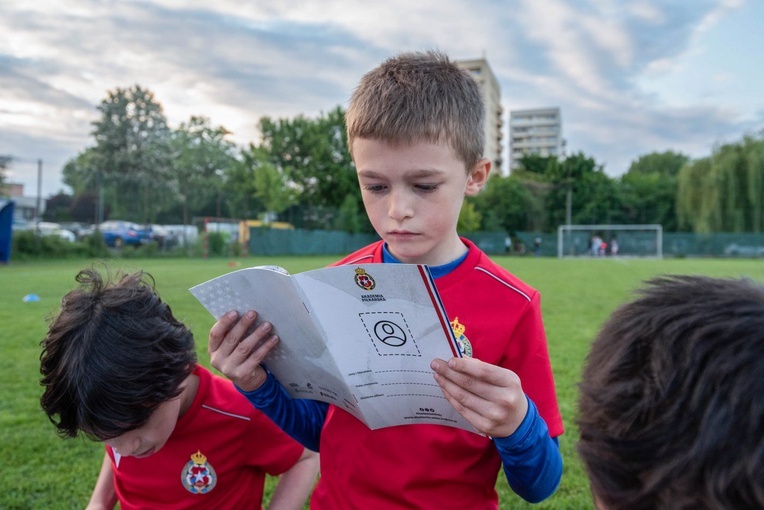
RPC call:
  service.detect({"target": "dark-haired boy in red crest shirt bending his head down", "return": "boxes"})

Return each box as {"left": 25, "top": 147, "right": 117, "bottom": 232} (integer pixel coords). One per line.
{"left": 40, "top": 269, "right": 318, "bottom": 510}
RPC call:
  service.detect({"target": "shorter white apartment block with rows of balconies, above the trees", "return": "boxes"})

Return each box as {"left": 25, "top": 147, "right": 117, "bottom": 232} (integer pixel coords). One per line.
{"left": 509, "top": 108, "right": 565, "bottom": 171}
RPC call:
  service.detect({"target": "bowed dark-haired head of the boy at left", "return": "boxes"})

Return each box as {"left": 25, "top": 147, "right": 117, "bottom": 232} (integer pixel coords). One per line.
{"left": 40, "top": 268, "right": 196, "bottom": 456}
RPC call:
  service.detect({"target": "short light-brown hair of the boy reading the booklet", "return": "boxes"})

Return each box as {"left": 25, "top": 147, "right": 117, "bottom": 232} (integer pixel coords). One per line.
{"left": 345, "top": 51, "right": 485, "bottom": 170}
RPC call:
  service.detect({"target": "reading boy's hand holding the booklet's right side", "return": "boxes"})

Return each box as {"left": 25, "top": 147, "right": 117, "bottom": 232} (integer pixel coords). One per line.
{"left": 430, "top": 358, "right": 528, "bottom": 437}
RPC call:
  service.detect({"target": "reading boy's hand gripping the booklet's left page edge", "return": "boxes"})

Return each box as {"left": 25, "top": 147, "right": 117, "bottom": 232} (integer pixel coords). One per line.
{"left": 208, "top": 310, "right": 278, "bottom": 391}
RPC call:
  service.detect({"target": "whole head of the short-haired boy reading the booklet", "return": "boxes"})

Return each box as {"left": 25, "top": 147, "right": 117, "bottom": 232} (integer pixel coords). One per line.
{"left": 346, "top": 51, "right": 491, "bottom": 264}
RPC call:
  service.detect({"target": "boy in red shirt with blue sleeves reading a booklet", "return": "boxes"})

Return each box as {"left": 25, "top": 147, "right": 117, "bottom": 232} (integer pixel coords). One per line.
{"left": 209, "top": 52, "right": 563, "bottom": 509}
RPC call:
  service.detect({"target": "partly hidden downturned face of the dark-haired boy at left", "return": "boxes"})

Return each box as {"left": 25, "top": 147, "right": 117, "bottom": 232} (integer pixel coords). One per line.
{"left": 104, "top": 397, "right": 181, "bottom": 459}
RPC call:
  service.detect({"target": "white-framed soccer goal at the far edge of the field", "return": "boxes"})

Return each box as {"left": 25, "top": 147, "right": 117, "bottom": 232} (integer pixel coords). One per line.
{"left": 557, "top": 225, "right": 663, "bottom": 258}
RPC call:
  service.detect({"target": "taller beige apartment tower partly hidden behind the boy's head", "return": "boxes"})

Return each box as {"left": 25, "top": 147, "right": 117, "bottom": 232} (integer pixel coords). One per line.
{"left": 456, "top": 58, "right": 504, "bottom": 173}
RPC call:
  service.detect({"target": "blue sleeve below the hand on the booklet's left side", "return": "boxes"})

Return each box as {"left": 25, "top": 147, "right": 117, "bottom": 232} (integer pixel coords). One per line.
{"left": 236, "top": 372, "right": 329, "bottom": 452}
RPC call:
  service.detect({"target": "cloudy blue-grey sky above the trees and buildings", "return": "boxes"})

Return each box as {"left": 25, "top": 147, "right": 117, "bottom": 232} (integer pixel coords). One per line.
{"left": 0, "top": 0, "right": 764, "bottom": 196}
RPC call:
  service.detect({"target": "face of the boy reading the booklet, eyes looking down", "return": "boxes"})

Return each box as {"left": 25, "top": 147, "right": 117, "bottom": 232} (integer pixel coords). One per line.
{"left": 353, "top": 138, "right": 491, "bottom": 266}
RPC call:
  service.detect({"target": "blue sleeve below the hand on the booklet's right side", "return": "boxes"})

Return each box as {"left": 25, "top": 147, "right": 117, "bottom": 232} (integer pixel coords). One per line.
{"left": 493, "top": 396, "right": 562, "bottom": 503}
